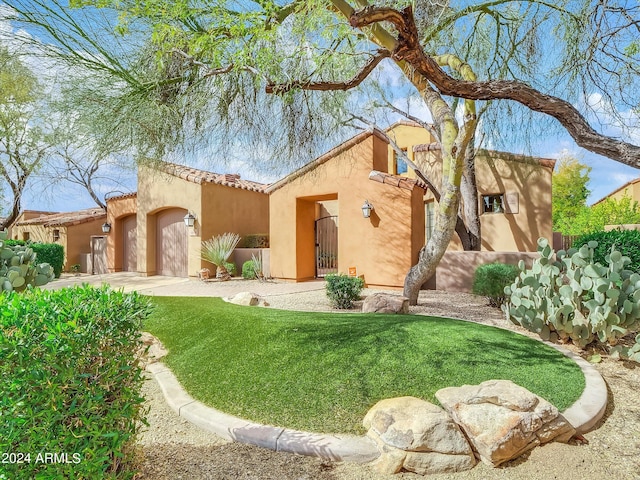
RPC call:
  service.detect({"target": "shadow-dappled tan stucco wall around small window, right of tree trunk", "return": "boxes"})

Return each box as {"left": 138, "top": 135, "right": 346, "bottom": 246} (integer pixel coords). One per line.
{"left": 416, "top": 151, "right": 552, "bottom": 252}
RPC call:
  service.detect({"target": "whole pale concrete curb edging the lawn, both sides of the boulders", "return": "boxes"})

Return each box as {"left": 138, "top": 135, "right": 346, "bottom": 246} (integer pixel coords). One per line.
{"left": 147, "top": 328, "right": 608, "bottom": 463}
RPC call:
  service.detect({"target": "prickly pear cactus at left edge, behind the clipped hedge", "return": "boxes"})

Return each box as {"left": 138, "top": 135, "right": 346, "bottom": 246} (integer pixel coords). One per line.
{"left": 0, "top": 230, "right": 54, "bottom": 292}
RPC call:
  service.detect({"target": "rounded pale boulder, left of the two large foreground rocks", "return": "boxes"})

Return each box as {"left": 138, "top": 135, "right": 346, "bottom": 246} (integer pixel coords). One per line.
{"left": 363, "top": 397, "right": 476, "bottom": 475}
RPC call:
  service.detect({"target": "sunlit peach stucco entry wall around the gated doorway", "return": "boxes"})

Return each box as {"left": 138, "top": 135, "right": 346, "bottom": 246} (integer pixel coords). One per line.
{"left": 270, "top": 135, "right": 424, "bottom": 286}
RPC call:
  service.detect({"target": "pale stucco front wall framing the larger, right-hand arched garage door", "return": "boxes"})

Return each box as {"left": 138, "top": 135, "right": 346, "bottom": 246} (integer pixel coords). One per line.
{"left": 137, "top": 166, "right": 203, "bottom": 276}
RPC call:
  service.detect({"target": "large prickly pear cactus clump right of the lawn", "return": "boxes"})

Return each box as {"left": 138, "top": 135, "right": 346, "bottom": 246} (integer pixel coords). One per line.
{"left": 502, "top": 238, "right": 640, "bottom": 361}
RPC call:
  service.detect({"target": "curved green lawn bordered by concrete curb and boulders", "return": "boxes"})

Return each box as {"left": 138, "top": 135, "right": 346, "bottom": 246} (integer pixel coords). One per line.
{"left": 145, "top": 297, "right": 584, "bottom": 433}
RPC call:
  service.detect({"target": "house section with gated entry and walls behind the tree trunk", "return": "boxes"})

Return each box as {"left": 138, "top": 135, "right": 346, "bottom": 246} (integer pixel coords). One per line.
{"left": 266, "top": 122, "right": 555, "bottom": 287}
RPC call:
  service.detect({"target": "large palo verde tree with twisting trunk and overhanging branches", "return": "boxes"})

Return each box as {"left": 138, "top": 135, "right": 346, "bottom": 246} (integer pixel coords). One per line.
{"left": 7, "top": 0, "right": 640, "bottom": 304}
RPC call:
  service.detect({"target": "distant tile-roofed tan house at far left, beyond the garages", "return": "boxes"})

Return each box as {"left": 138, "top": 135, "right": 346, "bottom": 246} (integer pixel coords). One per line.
{"left": 12, "top": 207, "right": 107, "bottom": 271}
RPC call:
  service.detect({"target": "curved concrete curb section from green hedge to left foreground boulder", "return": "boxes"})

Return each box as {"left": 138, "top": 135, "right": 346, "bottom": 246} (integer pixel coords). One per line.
{"left": 147, "top": 362, "right": 380, "bottom": 463}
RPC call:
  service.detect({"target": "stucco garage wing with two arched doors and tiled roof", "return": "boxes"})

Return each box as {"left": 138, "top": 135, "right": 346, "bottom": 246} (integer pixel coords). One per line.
{"left": 107, "top": 163, "right": 269, "bottom": 277}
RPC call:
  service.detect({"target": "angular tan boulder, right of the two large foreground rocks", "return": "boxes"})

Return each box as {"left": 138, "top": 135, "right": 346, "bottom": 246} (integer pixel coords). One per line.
{"left": 436, "top": 380, "right": 575, "bottom": 466}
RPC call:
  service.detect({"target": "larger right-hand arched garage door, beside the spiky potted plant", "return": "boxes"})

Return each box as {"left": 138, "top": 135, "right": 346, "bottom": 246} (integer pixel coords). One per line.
{"left": 156, "top": 208, "right": 188, "bottom": 277}
